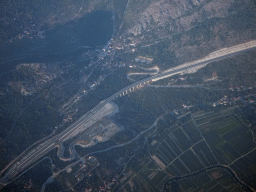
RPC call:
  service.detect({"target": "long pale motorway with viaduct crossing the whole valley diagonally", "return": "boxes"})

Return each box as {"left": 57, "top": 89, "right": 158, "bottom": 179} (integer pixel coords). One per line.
{"left": 0, "top": 40, "right": 256, "bottom": 186}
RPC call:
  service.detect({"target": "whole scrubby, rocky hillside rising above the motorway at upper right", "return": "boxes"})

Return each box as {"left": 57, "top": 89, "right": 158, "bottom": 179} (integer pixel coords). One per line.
{"left": 116, "top": 0, "right": 256, "bottom": 68}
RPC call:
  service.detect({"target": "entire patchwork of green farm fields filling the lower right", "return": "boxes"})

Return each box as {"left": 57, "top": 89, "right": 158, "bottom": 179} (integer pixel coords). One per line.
{"left": 118, "top": 107, "right": 256, "bottom": 192}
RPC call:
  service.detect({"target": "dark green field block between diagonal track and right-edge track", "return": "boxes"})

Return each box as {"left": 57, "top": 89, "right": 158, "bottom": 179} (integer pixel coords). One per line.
{"left": 193, "top": 107, "right": 256, "bottom": 165}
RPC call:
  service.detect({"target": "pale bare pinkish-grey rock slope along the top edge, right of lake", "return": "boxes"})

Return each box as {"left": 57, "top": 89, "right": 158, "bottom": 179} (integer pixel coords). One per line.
{"left": 126, "top": 0, "right": 234, "bottom": 36}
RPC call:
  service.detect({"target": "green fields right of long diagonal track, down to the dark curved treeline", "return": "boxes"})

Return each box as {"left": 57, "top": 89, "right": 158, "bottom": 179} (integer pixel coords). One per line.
{"left": 193, "top": 107, "right": 256, "bottom": 188}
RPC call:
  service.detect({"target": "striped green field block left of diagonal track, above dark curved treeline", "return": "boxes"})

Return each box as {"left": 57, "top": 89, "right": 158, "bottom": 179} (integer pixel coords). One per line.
{"left": 151, "top": 113, "right": 217, "bottom": 176}
